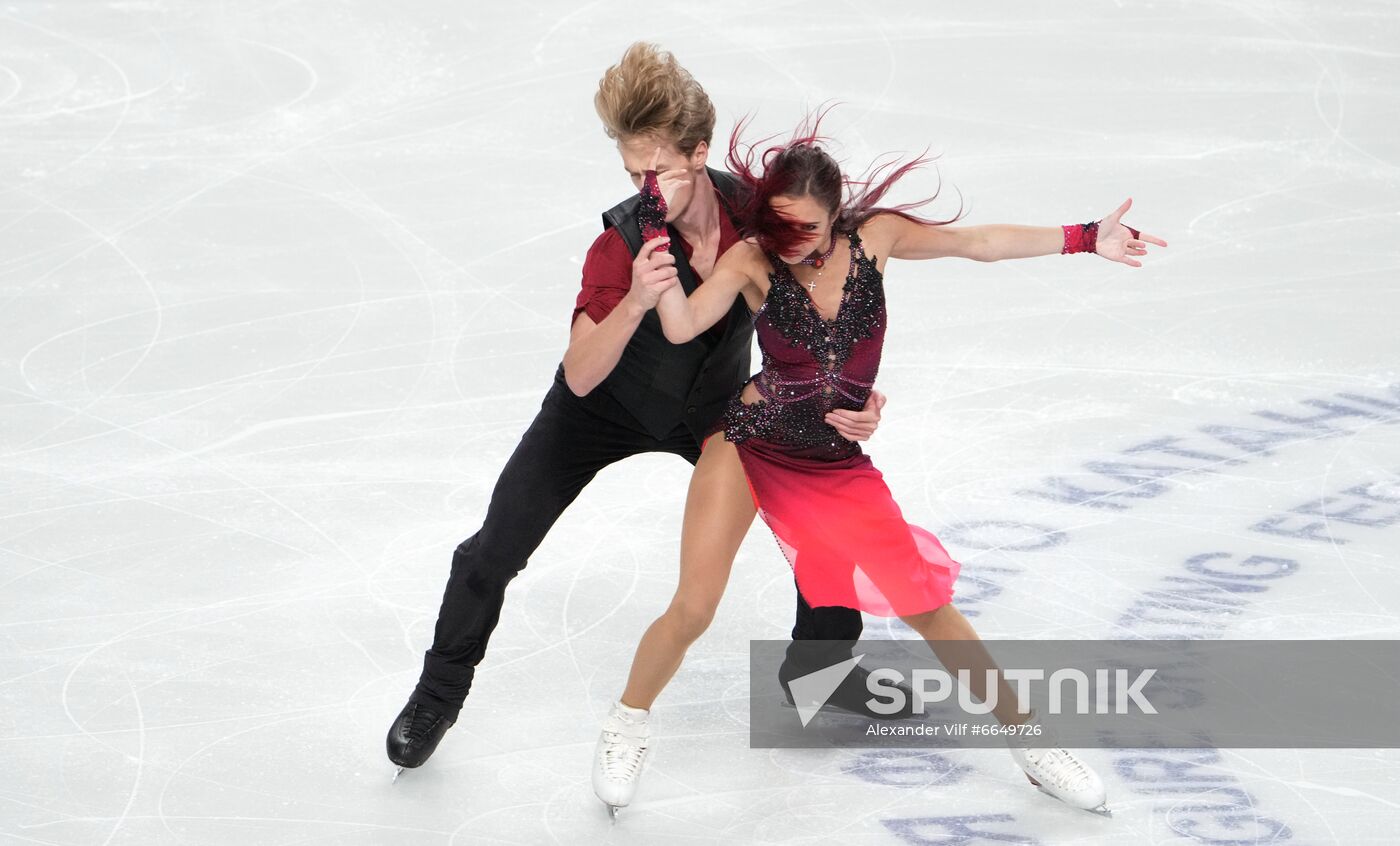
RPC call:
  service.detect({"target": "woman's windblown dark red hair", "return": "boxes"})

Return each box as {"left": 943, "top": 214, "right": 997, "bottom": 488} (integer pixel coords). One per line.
{"left": 725, "top": 106, "right": 963, "bottom": 255}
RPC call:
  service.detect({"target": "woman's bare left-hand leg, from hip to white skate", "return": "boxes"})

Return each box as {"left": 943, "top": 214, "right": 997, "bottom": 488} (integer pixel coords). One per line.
{"left": 622, "top": 436, "right": 755, "bottom": 709}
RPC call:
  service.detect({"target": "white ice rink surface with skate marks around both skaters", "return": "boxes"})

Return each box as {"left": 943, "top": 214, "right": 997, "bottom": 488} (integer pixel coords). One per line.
{"left": 0, "top": 0, "right": 1400, "bottom": 846}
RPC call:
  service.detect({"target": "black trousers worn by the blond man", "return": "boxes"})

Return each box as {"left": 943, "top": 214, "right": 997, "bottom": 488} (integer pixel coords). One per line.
{"left": 413, "top": 380, "right": 861, "bottom": 720}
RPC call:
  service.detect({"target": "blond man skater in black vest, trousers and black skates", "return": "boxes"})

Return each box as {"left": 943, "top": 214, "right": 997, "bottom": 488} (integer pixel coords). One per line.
{"left": 386, "top": 43, "right": 885, "bottom": 772}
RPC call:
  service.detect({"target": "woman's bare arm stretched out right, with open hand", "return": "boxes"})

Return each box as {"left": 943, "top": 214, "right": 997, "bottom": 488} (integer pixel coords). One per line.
{"left": 865, "top": 199, "right": 1166, "bottom": 268}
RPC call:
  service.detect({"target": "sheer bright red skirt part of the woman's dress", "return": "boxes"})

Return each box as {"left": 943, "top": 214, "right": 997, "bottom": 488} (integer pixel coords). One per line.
{"left": 711, "top": 437, "right": 962, "bottom": 616}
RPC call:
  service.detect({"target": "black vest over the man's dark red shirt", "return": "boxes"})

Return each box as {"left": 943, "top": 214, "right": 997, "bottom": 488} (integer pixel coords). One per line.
{"left": 560, "top": 168, "right": 753, "bottom": 441}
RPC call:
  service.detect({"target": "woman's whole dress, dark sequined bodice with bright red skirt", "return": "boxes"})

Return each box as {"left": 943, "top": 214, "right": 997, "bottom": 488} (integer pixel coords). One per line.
{"left": 717, "top": 233, "right": 959, "bottom": 616}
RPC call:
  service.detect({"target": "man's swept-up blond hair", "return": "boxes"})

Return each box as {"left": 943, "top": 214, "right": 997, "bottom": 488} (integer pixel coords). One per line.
{"left": 594, "top": 41, "right": 714, "bottom": 155}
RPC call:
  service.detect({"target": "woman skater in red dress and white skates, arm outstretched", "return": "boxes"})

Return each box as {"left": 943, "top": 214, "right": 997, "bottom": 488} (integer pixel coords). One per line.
{"left": 592, "top": 115, "right": 1166, "bottom": 817}
